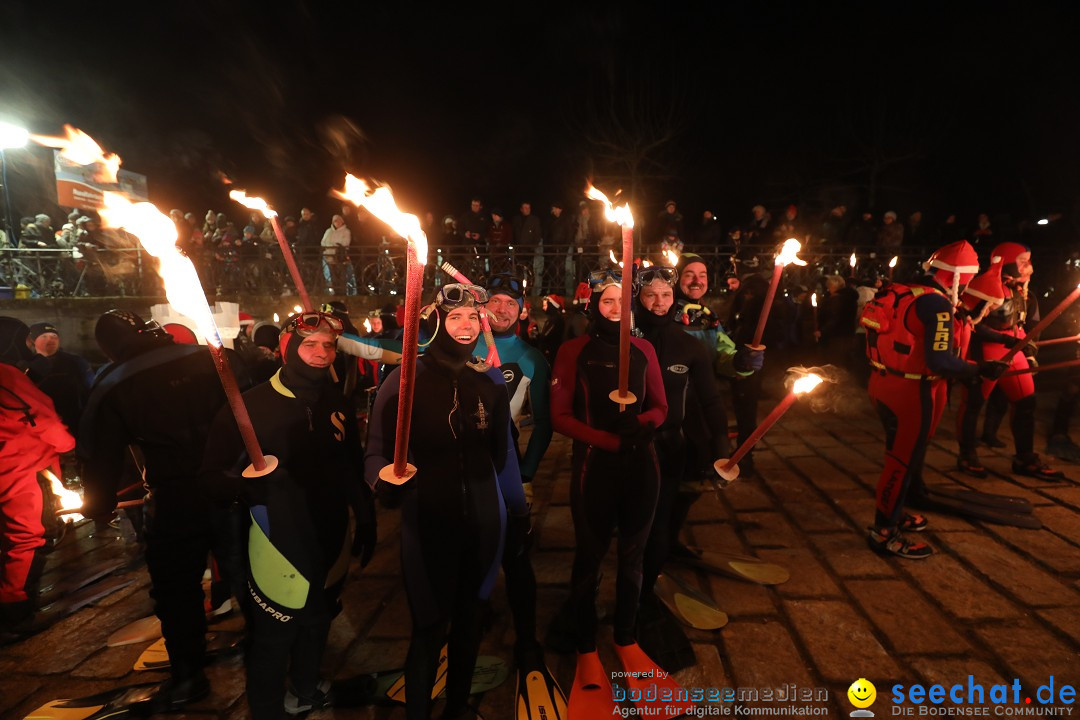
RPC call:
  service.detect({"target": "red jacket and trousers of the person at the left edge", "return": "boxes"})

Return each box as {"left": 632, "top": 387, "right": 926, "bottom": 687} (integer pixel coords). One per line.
{"left": 0, "top": 345, "right": 75, "bottom": 641}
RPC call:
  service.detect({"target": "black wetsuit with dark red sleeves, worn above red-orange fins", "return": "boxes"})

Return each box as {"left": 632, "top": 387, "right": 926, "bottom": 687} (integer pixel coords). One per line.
{"left": 551, "top": 317, "right": 667, "bottom": 652}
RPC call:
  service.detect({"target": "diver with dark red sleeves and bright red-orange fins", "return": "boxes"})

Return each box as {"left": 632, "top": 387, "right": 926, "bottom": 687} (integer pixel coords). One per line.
{"left": 549, "top": 270, "right": 691, "bottom": 718}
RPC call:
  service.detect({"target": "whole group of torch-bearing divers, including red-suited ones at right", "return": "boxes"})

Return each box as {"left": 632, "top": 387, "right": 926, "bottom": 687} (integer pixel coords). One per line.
{"left": 12, "top": 235, "right": 1075, "bottom": 720}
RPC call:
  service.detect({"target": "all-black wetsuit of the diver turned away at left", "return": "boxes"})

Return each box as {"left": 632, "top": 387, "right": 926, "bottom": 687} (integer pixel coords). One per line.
{"left": 78, "top": 339, "right": 225, "bottom": 680}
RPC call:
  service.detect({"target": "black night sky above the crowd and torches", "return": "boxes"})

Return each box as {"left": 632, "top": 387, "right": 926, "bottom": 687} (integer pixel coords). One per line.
{"left": 0, "top": 0, "right": 1080, "bottom": 231}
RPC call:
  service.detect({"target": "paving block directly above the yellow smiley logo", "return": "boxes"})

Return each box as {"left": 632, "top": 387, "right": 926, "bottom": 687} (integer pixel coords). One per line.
{"left": 783, "top": 600, "right": 900, "bottom": 684}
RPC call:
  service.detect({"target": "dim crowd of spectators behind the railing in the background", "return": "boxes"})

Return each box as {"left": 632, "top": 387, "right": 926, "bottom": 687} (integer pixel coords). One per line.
{"left": 0, "top": 198, "right": 1076, "bottom": 296}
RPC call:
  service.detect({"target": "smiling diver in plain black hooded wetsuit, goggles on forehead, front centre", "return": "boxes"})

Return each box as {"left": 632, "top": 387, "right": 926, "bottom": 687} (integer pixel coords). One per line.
{"left": 365, "top": 284, "right": 528, "bottom": 720}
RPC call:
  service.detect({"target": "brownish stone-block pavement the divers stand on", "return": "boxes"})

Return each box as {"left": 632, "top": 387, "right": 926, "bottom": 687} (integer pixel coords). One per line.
{"left": 0, "top": 389, "right": 1080, "bottom": 720}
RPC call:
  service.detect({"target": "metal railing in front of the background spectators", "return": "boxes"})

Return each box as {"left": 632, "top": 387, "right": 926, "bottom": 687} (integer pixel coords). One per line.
{"left": 0, "top": 241, "right": 927, "bottom": 298}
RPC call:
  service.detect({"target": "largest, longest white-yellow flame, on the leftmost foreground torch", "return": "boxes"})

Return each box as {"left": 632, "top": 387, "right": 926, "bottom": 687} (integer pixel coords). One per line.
{"left": 99, "top": 192, "right": 221, "bottom": 348}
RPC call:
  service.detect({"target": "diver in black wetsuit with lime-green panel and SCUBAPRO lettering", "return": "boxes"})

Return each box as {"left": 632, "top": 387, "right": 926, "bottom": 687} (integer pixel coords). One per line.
{"left": 202, "top": 312, "right": 376, "bottom": 720}
